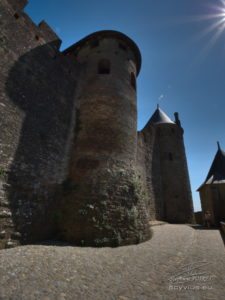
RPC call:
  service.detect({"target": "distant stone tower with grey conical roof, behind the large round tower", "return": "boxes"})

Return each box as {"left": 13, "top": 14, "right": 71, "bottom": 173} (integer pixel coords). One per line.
{"left": 143, "top": 107, "right": 193, "bottom": 223}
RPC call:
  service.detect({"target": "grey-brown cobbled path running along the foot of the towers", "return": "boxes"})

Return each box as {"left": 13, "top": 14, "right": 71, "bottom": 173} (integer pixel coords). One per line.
{"left": 0, "top": 224, "right": 225, "bottom": 300}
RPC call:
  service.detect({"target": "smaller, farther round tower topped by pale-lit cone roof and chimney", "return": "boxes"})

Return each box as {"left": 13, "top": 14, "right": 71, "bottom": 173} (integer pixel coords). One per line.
{"left": 145, "top": 107, "right": 194, "bottom": 223}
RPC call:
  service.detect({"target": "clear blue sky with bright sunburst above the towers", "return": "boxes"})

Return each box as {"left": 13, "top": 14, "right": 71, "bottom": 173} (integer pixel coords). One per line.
{"left": 25, "top": 0, "right": 225, "bottom": 210}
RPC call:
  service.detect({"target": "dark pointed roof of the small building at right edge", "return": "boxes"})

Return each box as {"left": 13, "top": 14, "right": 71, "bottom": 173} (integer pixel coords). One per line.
{"left": 198, "top": 142, "right": 225, "bottom": 190}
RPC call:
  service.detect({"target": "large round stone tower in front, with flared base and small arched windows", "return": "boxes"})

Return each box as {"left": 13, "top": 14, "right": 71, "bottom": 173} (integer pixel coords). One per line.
{"left": 61, "top": 31, "right": 150, "bottom": 246}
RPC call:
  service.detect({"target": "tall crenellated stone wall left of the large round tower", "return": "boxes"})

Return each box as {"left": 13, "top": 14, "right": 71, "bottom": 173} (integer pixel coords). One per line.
{"left": 0, "top": 0, "right": 78, "bottom": 248}
